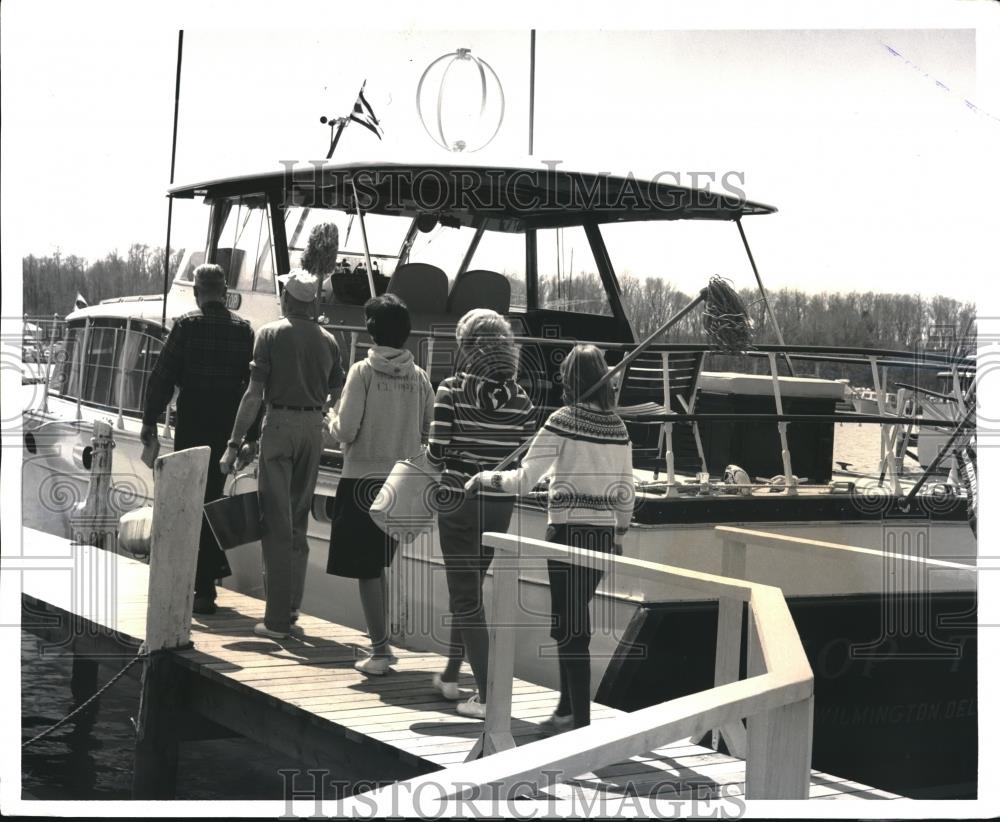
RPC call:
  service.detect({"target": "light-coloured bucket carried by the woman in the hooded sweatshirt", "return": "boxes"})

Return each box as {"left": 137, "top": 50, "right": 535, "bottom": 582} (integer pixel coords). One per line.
{"left": 369, "top": 451, "right": 441, "bottom": 544}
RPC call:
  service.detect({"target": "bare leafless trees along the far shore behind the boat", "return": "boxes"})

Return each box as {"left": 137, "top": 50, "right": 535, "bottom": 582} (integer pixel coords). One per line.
{"left": 23, "top": 249, "right": 976, "bottom": 385}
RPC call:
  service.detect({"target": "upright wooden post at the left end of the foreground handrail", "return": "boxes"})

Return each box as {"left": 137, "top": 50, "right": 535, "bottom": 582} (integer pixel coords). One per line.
{"left": 466, "top": 546, "right": 520, "bottom": 761}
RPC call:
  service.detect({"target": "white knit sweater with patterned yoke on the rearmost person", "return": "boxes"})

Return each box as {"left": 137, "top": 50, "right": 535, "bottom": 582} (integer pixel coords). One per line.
{"left": 480, "top": 406, "right": 635, "bottom": 532}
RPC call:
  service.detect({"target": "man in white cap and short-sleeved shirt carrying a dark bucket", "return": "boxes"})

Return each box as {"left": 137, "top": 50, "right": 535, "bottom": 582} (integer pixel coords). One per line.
{"left": 219, "top": 270, "right": 344, "bottom": 639}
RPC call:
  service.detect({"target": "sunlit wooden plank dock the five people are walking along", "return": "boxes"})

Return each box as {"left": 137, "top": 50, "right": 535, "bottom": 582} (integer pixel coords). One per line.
{"left": 12, "top": 529, "right": 897, "bottom": 799}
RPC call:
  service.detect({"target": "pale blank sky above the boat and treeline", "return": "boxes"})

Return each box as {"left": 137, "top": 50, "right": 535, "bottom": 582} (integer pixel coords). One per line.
{"left": 3, "top": 3, "right": 1000, "bottom": 300}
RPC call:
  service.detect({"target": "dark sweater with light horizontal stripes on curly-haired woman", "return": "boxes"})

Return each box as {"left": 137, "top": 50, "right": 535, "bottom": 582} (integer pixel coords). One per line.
{"left": 428, "top": 372, "right": 536, "bottom": 488}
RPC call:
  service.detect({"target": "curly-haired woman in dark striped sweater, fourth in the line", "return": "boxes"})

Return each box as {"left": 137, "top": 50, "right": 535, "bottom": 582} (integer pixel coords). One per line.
{"left": 428, "top": 308, "right": 536, "bottom": 718}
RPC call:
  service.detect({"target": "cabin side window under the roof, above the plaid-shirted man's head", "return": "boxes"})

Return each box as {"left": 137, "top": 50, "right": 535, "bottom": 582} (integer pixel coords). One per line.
{"left": 215, "top": 196, "right": 275, "bottom": 294}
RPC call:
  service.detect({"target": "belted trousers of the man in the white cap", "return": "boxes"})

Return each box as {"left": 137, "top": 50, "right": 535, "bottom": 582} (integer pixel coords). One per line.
{"left": 257, "top": 408, "right": 323, "bottom": 633}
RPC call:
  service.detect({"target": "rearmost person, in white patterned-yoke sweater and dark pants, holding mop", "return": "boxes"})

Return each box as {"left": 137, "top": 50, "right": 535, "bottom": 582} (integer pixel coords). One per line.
{"left": 466, "top": 345, "right": 635, "bottom": 730}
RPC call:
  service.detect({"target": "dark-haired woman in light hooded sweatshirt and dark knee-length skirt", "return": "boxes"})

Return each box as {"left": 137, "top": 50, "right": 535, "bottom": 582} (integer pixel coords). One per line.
{"left": 326, "top": 294, "right": 434, "bottom": 676}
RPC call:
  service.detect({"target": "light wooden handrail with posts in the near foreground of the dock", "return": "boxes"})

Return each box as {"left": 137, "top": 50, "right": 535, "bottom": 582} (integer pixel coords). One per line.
{"left": 350, "top": 533, "right": 813, "bottom": 801}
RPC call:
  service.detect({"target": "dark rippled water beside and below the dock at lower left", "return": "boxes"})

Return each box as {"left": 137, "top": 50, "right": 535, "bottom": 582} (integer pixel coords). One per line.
{"left": 21, "top": 631, "right": 305, "bottom": 800}
